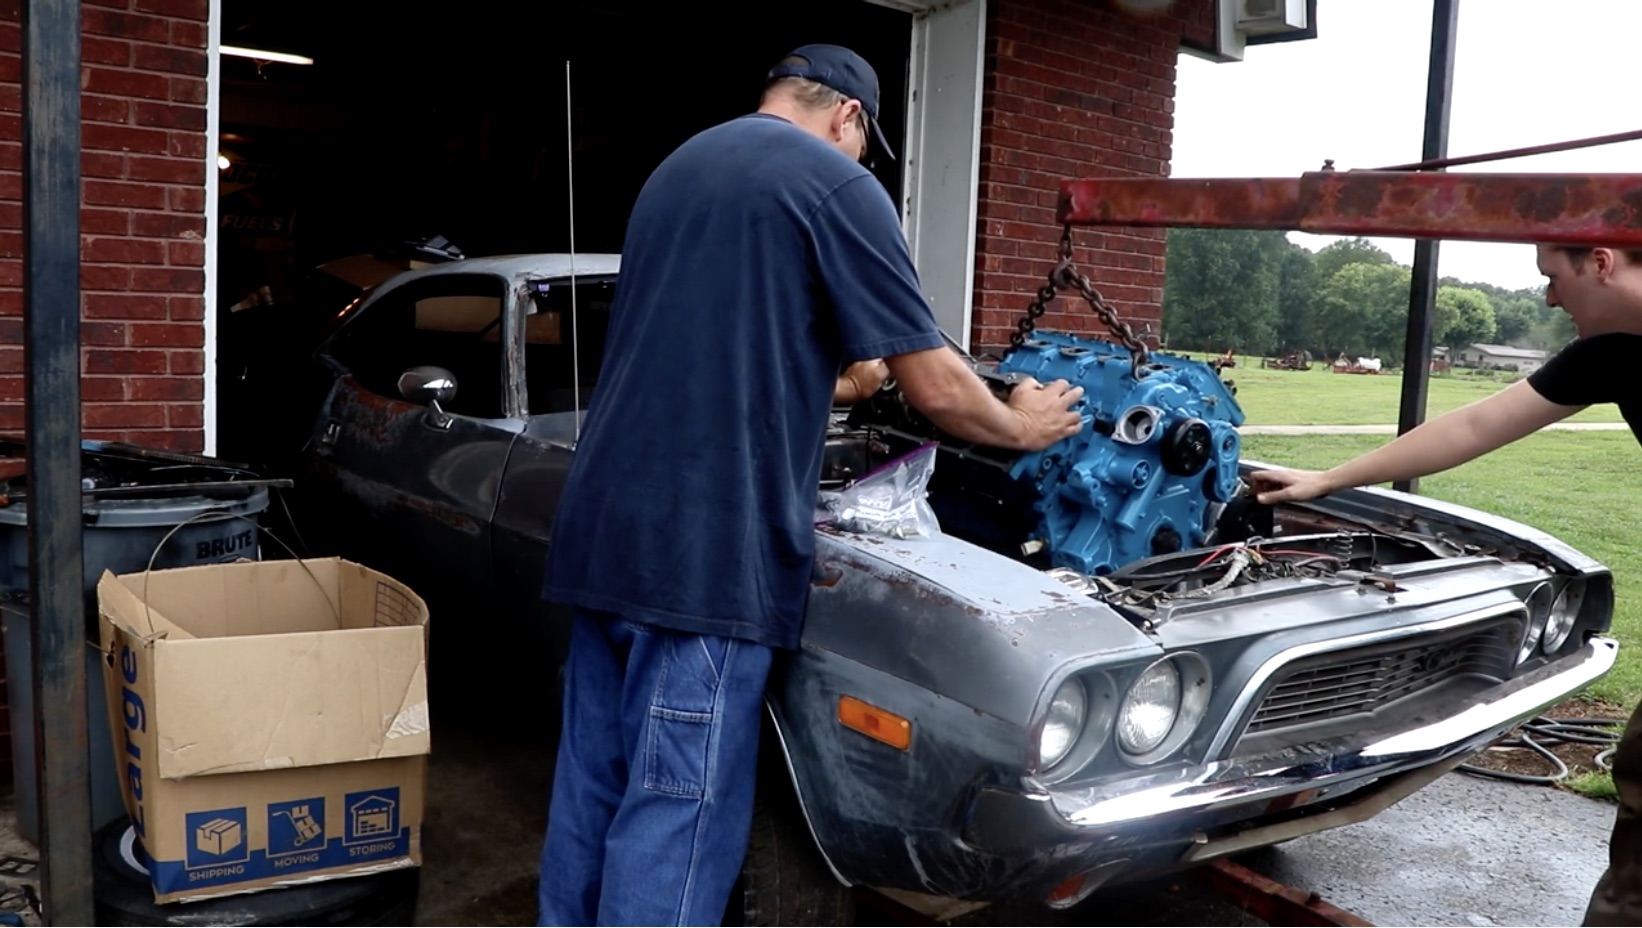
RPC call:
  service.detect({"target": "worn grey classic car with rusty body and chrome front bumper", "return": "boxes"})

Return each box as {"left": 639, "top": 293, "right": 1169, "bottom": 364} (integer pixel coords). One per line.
{"left": 292, "top": 256, "right": 1616, "bottom": 905}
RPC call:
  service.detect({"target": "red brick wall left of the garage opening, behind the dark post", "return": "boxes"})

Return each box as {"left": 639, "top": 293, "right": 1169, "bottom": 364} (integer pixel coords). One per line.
{"left": 0, "top": 0, "right": 209, "bottom": 450}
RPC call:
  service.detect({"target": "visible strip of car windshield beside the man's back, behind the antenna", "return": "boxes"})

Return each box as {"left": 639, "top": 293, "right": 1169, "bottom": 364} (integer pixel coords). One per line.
{"left": 524, "top": 278, "right": 616, "bottom": 416}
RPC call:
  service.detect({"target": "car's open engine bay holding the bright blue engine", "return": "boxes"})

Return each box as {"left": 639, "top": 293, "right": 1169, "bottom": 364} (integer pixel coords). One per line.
{"left": 823, "top": 330, "right": 1464, "bottom": 609}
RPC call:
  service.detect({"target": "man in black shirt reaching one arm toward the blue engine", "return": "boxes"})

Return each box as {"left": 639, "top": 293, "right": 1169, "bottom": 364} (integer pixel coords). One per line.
{"left": 1250, "top": 245, "right": 1642, "bottom": 925}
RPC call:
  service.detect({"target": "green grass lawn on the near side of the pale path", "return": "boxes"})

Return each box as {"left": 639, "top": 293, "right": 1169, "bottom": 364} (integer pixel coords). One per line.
{"left": 1238, "top": 420, "right": 1642, "bottom": 710}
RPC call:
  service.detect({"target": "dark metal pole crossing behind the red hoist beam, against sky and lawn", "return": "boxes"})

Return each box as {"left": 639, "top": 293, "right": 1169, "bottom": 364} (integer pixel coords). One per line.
{"left": 1392, "top": 0, "right": 1460, "bottom": 493}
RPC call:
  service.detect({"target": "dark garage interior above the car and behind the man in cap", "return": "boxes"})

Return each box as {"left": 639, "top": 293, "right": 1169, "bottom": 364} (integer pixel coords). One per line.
{"left": 215, "top": 0, "right": 911, "bottom": 457}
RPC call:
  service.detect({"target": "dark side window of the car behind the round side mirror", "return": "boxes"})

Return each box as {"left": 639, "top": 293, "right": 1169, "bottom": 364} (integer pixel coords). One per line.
{"left": 316, "top": 276, "right": 506, "bottom": 419}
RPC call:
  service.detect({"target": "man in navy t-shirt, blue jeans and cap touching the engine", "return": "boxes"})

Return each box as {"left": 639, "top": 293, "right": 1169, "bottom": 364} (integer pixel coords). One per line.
{"left": 540, "top": 46, "right": 1082, "bottom": 925}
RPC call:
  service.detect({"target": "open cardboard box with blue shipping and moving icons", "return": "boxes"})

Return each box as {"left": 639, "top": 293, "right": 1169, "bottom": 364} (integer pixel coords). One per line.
{"left": 97, "top": 558, "right": 430, "bottom": 902}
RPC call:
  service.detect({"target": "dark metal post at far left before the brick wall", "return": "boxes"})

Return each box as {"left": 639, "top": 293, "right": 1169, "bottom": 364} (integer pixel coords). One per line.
{"left": 23, "top": 0, "right": 94, "bottom": 925}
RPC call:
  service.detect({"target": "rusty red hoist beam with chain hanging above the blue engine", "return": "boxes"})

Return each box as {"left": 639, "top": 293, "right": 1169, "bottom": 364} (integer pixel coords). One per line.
{"left": 1057, "top": 171, "right": 1642, "bottom": 248}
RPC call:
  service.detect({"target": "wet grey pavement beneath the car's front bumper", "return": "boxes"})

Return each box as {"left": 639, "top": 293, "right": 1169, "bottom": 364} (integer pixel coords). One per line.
{"left": 952, "top": 774, "right": 1614, "bottom": 926}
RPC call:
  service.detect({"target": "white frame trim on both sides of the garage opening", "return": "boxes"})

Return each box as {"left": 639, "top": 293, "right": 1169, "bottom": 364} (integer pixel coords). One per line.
{"left": 202, "top": 0, "right": 987, "bottom": 455}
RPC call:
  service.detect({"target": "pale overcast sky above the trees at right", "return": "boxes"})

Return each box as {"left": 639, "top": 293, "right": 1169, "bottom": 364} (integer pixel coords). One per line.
{"left": 1172, "top": 0, "right": 1642, "bottom": 287}
